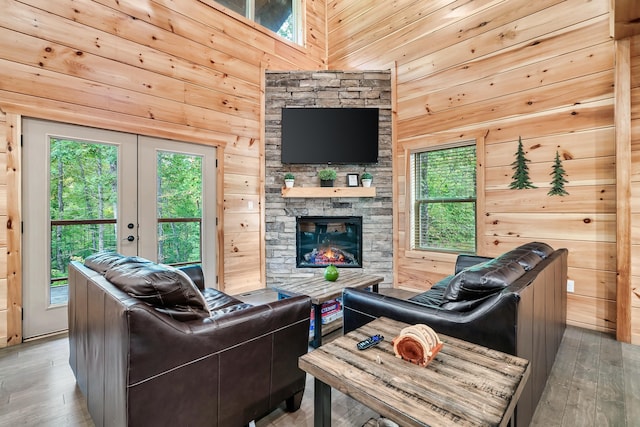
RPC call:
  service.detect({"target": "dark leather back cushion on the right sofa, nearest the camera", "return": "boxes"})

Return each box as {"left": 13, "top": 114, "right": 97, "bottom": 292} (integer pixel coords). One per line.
{"left": 443, "top": 258, "right": 525, "bottom": 301}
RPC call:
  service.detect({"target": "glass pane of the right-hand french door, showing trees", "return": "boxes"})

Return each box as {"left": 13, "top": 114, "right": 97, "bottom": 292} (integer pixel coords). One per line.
{"left": 157, "top": 151, "right": 202, "bottom": 265}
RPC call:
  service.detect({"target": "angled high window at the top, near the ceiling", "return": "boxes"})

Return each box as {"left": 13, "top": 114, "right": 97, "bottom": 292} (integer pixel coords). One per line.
{"left": 215, "top": 0, "right": 302, "bottom": 44}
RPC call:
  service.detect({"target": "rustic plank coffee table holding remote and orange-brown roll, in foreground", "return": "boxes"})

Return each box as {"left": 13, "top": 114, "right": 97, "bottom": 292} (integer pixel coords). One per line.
{"left": 298, "top": 318, "right": 530, "bottom": 427}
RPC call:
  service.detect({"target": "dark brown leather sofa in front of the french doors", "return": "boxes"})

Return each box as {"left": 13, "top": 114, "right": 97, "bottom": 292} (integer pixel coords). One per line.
{"left": 69, "top": 253, "right": 311, "bottom": 427}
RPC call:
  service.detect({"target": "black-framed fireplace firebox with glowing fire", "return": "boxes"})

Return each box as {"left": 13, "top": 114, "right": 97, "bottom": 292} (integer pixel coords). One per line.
{"left": 296, "top": 216, "right": 362, "bottom": 268}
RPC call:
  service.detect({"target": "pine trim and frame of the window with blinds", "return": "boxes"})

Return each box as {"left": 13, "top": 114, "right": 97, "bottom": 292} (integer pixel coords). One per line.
{"left": 405, "top": 140, "right": 484, "bottom": 254}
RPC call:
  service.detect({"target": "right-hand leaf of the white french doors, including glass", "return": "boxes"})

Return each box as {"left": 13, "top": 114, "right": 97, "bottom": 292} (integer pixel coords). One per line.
{"left": 138, "top": 136, "right": 217, "bottom": 287}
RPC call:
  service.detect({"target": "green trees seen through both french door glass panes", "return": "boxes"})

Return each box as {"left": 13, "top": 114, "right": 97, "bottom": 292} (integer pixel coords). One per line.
{"left": 49, "top": 145, "right": 202, "bottom": 304}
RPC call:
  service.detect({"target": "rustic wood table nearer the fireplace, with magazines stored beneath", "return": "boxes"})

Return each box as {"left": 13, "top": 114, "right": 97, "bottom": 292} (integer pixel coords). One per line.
{"left": 273, "top": 270, "right": 384, "bottom": 348}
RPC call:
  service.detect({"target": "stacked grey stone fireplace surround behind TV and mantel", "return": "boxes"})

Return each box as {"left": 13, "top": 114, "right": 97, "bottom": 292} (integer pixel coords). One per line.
{"left": 265, "top": 71, "right": 393, "bottom": 287}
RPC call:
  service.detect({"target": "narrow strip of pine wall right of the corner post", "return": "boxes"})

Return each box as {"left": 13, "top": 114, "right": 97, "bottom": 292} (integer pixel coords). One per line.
{"left": 631, "top": 36, "right": 640, "bottom": 344}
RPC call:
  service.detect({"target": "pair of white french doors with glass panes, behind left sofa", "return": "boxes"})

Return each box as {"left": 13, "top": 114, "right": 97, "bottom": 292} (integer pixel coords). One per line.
{"left": 22, "top": 119, "right": 217, "bottom": 338}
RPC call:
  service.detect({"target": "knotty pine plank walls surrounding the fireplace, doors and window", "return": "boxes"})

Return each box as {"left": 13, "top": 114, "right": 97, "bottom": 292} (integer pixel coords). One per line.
{"left": 0, "top": 0, "right": 640, "bottom": 346}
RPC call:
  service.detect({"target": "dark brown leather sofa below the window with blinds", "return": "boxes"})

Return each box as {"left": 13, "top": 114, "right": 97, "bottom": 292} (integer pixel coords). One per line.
{"left": 342, "top": 242, "right": 568, "bottom": 426}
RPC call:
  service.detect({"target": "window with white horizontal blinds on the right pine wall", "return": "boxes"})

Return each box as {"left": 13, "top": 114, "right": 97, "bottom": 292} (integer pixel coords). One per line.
{"left": 411, "top": 141, "right": 476, "bottom": 253}
